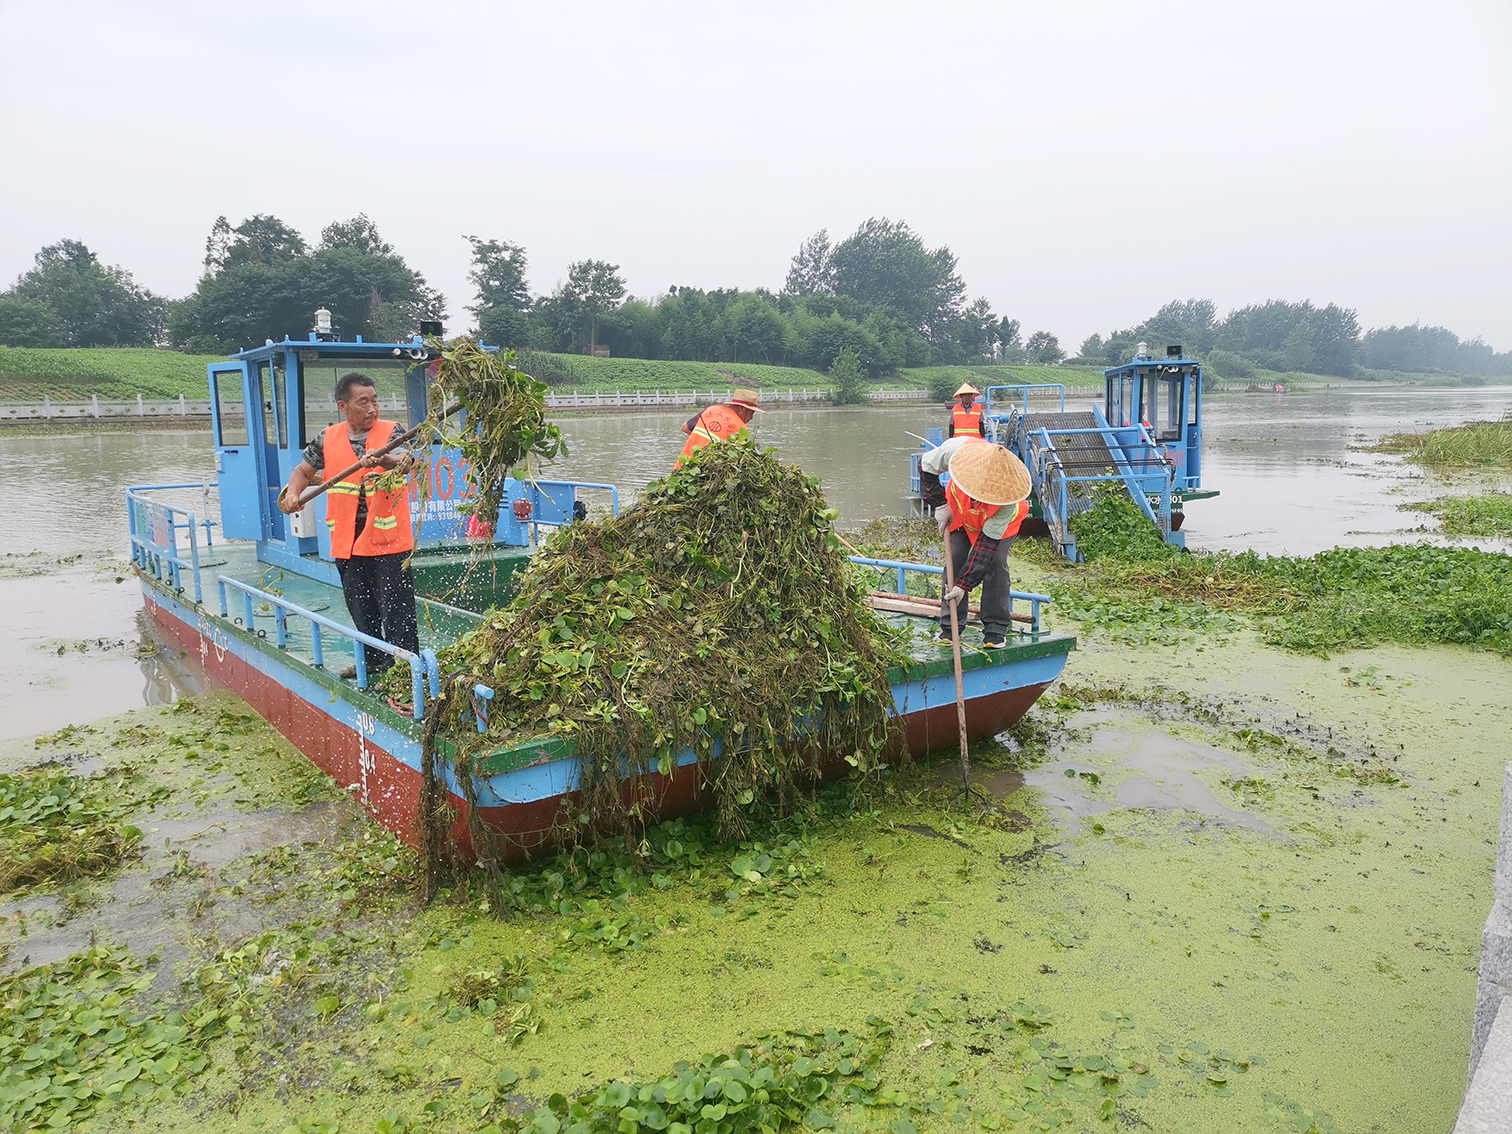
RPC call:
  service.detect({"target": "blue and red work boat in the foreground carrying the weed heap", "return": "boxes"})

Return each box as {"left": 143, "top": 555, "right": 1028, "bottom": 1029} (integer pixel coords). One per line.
{"left": 125, "top": 333, "right": 1075, "bottom": 859}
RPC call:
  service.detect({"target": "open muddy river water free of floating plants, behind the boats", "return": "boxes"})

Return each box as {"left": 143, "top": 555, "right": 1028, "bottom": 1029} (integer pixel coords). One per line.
{"left": 0, "top": 387, "right": 1512, "bottom": 739}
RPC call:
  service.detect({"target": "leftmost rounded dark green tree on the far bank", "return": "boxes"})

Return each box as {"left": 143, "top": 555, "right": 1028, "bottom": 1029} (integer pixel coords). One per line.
{"left": 9, "top": 240, "right": 168, "bottom": 346}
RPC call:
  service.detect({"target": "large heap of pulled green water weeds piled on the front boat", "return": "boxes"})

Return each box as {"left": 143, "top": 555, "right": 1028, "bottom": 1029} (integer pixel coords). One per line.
{"left": 429, "top": 442, "right": 904, "bottom": 876}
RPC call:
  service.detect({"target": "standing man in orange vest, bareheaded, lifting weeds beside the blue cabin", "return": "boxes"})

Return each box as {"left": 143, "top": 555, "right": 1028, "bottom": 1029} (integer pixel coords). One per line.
{"left": 278, "top": 373, "right": 420, "bottom": 677}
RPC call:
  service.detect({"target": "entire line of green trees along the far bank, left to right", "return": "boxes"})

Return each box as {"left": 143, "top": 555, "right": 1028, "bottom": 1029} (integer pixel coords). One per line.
{"left": 0, "top": 213, "right": 1512, "bottom": 380}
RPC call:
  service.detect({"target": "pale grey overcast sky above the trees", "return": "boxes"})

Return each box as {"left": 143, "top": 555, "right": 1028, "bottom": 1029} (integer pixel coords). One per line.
{"left": 0, "top": 0, "right": 1512, "bottom": 351}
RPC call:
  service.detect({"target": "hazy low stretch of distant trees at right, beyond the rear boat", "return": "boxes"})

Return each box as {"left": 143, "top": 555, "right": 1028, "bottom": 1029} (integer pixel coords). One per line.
{"left": 1077, "top": 299, "right": 1512, "bottom": 380}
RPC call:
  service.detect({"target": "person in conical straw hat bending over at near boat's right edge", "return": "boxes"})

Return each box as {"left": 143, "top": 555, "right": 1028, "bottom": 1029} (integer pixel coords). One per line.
{"left": 919, "top": 435, "right": 1030, "bottom": 649}
